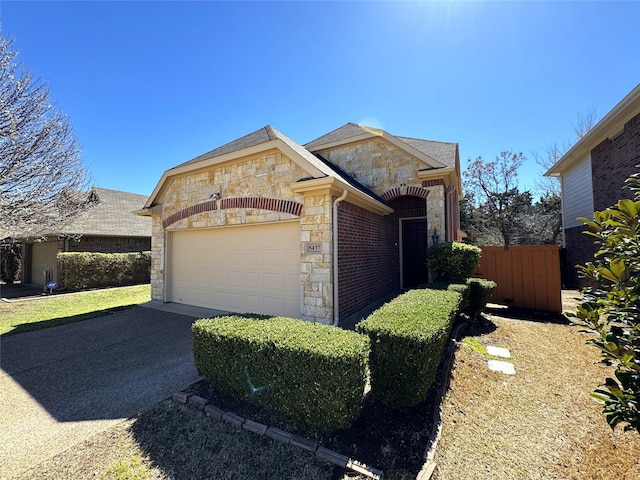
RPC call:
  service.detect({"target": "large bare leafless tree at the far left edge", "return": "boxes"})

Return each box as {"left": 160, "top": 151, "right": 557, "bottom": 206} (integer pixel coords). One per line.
{"left": 0, "top": 37, "right": 89, "bottom": 238}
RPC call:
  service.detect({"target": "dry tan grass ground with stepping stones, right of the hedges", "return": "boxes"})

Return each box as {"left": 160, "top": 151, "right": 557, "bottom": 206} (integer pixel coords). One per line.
{"left": 435, "top": 299, "right": 640, "bottom": 480}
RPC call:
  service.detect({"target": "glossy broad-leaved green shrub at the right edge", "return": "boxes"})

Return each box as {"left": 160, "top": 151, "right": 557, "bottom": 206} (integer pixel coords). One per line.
{"left": 573, "top": 168, "right": 640, "bottom": 433}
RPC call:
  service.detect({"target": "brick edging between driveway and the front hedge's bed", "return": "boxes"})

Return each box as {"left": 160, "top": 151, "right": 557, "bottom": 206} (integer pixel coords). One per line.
{"left": 172, "top": 392, "right": 382, "bottom": 480}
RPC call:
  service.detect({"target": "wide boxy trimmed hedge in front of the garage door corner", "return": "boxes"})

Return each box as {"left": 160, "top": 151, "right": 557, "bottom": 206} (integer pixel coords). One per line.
{"left": 192, "top": 316, "right": 369, "bottom": 432}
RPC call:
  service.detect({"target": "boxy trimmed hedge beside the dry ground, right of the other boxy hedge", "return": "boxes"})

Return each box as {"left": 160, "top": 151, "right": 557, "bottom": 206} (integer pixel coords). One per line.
{"left": 356, "top": 289, "right": 462, "bottom": 406}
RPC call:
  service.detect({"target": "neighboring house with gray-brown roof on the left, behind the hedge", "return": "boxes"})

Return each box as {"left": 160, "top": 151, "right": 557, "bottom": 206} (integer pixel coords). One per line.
{"left": 17, "top": 187, "right": 151, "bottom": 285}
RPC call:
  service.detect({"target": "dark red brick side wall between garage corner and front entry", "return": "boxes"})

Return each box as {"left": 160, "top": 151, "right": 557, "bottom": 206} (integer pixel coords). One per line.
{"left": 338, "top": 200, "right": 398, "bottom": 319}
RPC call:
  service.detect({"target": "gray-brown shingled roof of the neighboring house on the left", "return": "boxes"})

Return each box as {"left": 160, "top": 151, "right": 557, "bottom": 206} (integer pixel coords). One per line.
{"left": 54, "top": 187, "right": 151, "bottom": 237}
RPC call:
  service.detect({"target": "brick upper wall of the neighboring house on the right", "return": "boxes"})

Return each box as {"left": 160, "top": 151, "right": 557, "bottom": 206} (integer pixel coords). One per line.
{"left": 592, "top": 114, "right": 640, "bottom": 211}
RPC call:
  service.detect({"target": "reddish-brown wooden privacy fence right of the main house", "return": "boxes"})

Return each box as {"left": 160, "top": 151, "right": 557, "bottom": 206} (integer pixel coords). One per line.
{"left": 473, "top": 245, "right": 562, "bottom": 312}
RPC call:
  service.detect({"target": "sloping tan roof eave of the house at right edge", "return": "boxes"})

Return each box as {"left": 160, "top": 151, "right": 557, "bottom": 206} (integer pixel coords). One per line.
{"left": 545, "top": 84, "right": 640, "bottom": 177}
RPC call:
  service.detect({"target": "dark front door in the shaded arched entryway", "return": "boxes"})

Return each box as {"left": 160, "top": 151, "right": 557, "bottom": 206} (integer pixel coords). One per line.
{"left": 401, "top": 218, "right": 428, "bottom": 288}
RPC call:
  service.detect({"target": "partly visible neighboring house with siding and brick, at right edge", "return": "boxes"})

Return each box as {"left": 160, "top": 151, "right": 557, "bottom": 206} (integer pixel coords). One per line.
{"left": 545, "top": 84, "right": 640, "bottom": 288}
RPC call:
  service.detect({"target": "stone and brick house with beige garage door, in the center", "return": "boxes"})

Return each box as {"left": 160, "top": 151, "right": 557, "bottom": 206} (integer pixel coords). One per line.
{"left": 138, "top": 123, "right": 462, "bottom": 324}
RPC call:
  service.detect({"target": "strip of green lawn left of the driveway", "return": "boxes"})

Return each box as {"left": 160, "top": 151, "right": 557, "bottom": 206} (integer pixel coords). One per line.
{"left": 0, "top": 284, "right": 151, "bottom": 335}
